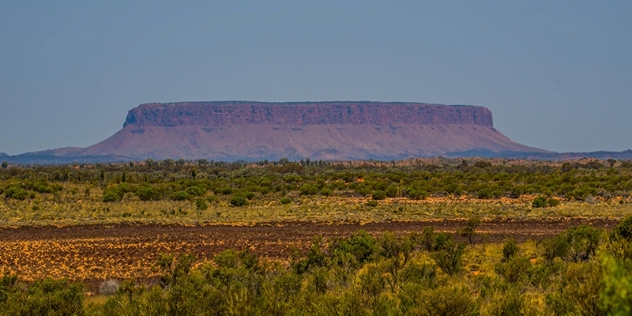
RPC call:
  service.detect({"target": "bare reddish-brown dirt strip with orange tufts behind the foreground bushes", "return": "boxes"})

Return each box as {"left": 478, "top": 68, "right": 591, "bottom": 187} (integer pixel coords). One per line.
{"left": 0, "top": 218, "right": 619, "bottom": 288}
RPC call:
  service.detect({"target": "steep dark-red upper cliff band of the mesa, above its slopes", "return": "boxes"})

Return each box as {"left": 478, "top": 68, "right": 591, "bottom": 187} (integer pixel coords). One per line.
{"left": 124, "top": 101, "right": 493, "bottom": 127}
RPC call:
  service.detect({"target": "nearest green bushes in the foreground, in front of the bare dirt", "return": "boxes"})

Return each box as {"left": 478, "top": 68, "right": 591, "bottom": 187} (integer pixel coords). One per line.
{"left": 0, "top": 217, "right": 632, "bottom": 315}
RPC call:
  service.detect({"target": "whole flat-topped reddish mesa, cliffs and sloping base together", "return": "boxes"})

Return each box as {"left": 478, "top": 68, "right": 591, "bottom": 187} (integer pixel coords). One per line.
{"left": 78, "top": 101, "right": 544, "bottom": 160}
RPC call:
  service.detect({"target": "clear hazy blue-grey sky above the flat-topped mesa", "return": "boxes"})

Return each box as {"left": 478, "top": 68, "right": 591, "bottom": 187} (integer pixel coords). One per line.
{"left": 0, "top": 0, "right": 632, "bottom": 154}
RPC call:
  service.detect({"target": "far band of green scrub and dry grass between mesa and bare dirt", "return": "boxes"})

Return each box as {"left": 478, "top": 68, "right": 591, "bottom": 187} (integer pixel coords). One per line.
{"left": 0, "top": 159, "right": 632, "bottom": 226}
